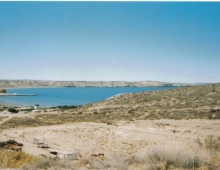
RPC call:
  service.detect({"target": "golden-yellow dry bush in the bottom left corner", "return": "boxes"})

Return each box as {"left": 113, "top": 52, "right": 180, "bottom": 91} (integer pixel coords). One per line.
{"left": 0, "top": 151, "right": 33, "bottom": 168}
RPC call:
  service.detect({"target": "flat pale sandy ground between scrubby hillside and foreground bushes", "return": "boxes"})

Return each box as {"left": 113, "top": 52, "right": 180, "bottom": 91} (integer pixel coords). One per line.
{"left": 0, "top": 115, "right": 220, "bottom": 158}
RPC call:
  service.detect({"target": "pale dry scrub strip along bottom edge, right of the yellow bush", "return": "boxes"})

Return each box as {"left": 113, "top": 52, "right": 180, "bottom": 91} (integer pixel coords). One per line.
{"left": 18, "top": 142, "right": 220, "bottom": 170}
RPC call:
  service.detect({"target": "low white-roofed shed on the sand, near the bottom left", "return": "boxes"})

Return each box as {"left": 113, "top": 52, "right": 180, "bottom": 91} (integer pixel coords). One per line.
{"left": 49, "top": 149, "right": 78, "bottom": 161}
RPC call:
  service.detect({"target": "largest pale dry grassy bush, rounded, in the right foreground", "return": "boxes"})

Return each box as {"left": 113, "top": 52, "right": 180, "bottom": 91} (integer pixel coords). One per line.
{"left": 133, "top": 144, "right": 203, "bottom": 170}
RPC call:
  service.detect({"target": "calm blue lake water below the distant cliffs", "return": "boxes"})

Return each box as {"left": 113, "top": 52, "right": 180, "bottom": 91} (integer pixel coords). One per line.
{"left": 0, "top": 87, "right": 175, "bottom": 107}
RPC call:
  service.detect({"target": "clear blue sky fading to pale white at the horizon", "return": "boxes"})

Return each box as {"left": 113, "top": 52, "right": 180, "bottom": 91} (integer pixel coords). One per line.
{"left": 0, "top": 1, "right": 220, "bottom": 83}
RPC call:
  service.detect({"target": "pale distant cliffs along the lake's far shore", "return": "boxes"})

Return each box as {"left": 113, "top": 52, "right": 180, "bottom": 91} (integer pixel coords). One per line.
{"left": 0, "top": 80, "right": 194, "bottom": 88}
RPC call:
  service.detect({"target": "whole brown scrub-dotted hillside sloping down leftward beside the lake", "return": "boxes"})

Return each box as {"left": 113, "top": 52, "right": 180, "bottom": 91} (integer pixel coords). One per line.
{"left": 1, "top": 84, "right": 220, "bottom": 128}
